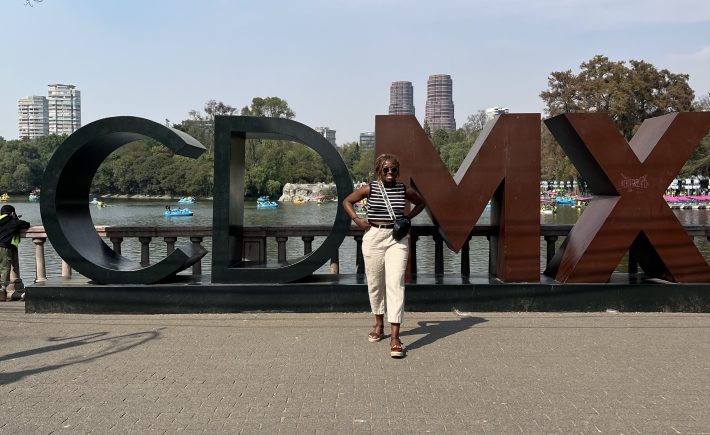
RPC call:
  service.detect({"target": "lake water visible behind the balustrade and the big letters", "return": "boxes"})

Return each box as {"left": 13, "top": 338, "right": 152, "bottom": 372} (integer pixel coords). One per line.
{"left": 10, "top": 199, "right": 710, "bottom": 284}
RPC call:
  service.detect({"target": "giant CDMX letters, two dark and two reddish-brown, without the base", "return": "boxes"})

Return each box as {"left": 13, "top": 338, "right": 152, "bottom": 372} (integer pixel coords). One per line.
{"left": 41, "top": 113, "right": 710, "bottom": 284}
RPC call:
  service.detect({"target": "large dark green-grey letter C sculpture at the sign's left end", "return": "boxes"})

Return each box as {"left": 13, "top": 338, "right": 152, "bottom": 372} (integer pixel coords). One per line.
{"left": 40, "top": 116, "right": 207, "bottom": 284}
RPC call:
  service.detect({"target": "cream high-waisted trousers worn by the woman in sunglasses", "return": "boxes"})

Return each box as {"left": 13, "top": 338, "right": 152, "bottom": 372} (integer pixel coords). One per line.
{"left": 362, "top": 227, "right": 409, "bottom": 323}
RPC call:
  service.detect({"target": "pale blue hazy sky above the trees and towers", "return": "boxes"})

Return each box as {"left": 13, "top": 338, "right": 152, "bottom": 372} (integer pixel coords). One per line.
{"left": 0, "top": 0, "right": 710, "bottom": 145}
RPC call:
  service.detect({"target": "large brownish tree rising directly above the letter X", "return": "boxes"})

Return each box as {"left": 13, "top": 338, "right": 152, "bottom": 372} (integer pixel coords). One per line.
{"left": 540, "top": 55, "right": 694, "bottom": 139}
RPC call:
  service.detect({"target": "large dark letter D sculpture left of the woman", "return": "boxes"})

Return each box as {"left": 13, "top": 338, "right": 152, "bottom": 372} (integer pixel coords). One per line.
{"left": 212, "top": 116, "right": 353, "bottom": 283}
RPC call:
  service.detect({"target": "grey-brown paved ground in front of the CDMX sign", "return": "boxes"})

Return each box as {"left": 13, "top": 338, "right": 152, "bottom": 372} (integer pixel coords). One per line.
{"left": 0, "top": 302, "right": 710, "bottom": 434}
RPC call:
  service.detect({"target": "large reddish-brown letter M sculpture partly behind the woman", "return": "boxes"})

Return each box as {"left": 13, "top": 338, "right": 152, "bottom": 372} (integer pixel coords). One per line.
{"left": 375, "top": 114, "right": 540, "bottom": 282}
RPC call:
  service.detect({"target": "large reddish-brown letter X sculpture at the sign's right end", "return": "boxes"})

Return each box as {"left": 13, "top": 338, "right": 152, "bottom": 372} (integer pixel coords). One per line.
{"left": 545, "top": 113, "right": 710, "bottom": 283}
